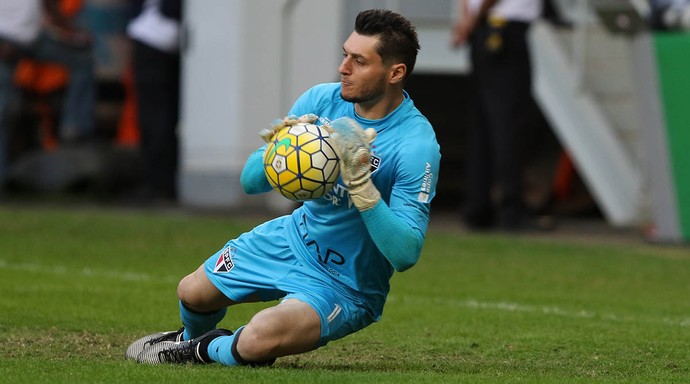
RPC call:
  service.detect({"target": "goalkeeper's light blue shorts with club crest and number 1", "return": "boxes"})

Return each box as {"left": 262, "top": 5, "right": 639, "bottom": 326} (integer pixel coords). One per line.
{"left": 204, "top": 216, "right": 375, "bottom": 346}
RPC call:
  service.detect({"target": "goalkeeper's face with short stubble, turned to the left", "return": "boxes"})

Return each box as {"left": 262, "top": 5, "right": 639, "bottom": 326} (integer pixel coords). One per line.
{"left": 338, "top": 32, "right": 387, "bottom": 103}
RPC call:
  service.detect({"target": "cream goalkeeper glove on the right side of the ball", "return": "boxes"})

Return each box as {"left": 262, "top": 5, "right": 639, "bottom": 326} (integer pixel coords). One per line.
{"left": 324, "top": 117, "right": 381, "bottom": 211}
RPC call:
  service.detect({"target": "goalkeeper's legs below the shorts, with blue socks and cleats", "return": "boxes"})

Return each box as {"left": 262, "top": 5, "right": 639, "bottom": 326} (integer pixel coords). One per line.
{"left": 137, "top": 266, "right": 321, "bottom": 366}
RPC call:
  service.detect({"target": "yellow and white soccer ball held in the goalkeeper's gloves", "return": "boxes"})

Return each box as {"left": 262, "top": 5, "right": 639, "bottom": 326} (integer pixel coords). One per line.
{"left": 264, "top": 124, "right": 340, "bottom": 201}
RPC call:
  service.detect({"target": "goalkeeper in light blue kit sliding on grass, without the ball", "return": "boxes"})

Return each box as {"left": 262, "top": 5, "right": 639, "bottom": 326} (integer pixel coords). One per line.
{"left": 125, "top": 10, "right": 441, "bottom": 366}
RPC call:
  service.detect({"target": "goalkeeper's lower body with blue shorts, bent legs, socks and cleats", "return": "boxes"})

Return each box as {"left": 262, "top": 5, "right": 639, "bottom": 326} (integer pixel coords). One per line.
{"left": 137, "top": 220, "right": 328, "bottom": 365}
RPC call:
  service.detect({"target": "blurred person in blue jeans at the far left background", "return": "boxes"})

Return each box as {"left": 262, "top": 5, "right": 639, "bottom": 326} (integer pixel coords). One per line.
{"left": 0, "top": 0, "right": 96, "bottom": 190}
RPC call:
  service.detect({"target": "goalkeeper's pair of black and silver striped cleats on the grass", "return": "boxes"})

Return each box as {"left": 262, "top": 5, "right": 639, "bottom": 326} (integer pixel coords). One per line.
{"left": 137, "top": 329, "right": 232, "bottom": 364}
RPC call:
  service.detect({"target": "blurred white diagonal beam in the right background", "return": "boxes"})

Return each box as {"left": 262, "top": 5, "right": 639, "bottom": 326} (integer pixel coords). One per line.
{"left": 530, "top": 0, "right": 644, "bottom": 226}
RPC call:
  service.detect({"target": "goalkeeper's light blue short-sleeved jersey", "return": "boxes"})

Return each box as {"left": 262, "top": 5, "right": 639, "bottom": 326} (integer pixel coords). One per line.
{"left": 266, "top": 83, "right": 441, "bottom": 320}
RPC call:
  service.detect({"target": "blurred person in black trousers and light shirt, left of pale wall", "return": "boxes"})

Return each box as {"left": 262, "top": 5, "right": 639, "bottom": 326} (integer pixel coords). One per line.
{"left": 127, "top": 0, "right": 182, "bottom": 203}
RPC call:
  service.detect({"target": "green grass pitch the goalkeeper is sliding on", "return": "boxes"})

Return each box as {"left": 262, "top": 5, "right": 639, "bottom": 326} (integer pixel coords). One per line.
{"left": 0, "top": 207, "right": 690, "bottom": 384}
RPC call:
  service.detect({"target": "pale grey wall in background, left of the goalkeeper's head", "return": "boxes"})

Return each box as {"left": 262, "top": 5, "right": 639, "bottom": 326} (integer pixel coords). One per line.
{"left": 180, "top": 0, "right": 342, "bottom": 208}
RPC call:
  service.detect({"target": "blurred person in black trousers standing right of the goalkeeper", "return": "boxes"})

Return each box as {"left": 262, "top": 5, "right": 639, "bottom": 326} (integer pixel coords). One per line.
{"left": 452, "top": 0, "right": 543, "bottom": 231}
